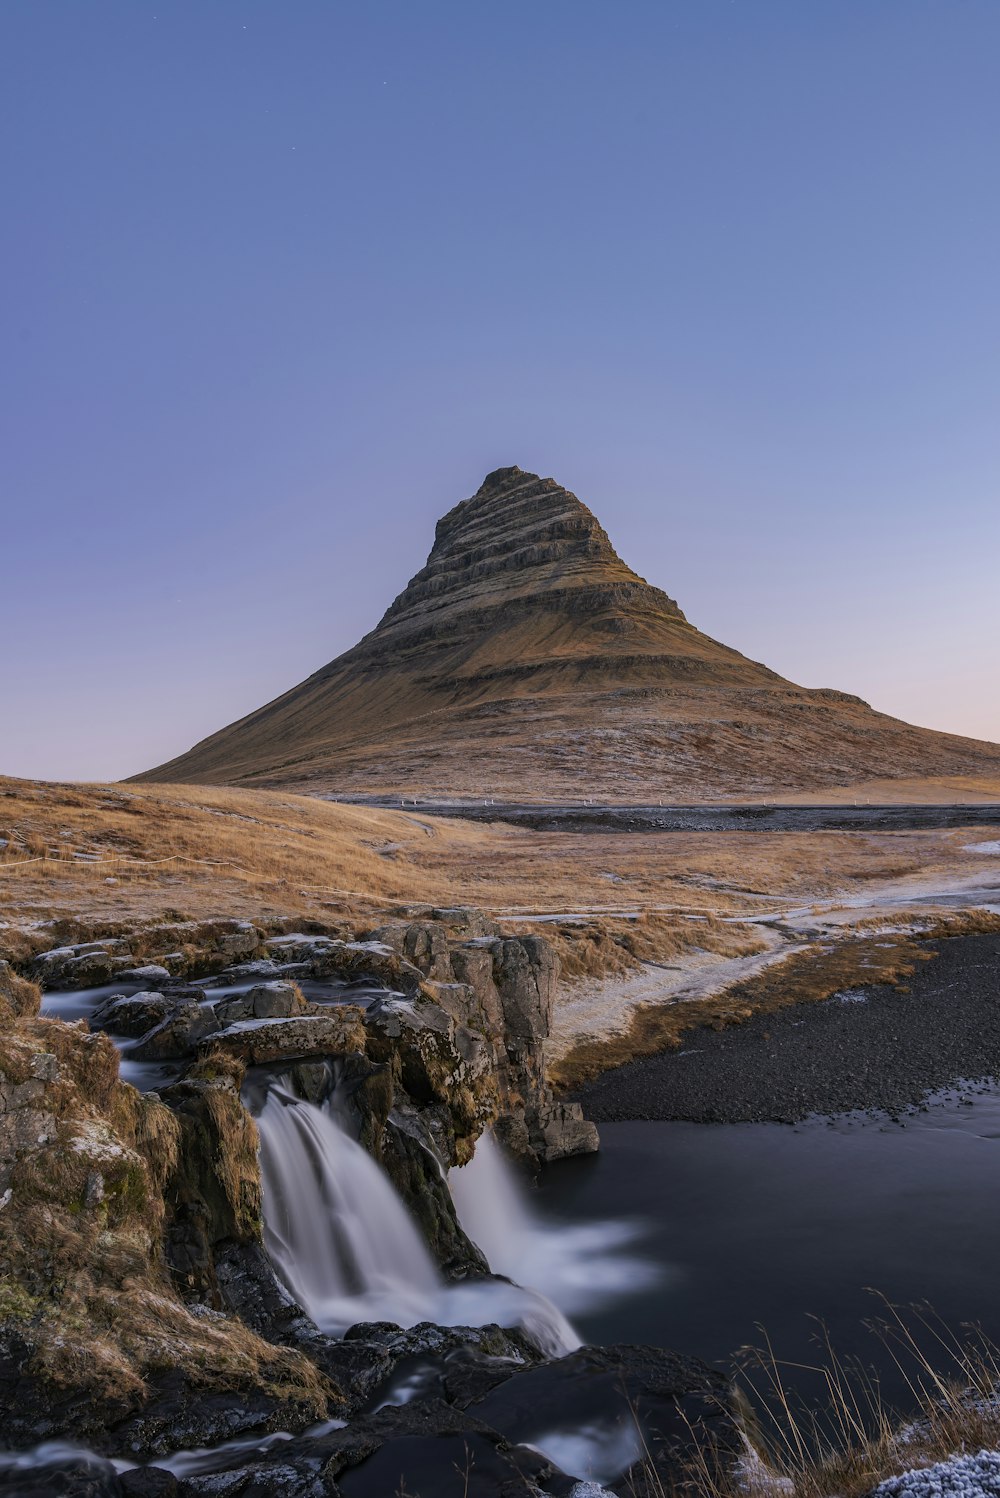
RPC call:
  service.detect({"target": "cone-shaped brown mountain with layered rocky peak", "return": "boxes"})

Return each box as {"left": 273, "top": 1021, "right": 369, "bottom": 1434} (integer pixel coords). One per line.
{"left": 136, "top": 467, "right": 1000, "bottom": 801}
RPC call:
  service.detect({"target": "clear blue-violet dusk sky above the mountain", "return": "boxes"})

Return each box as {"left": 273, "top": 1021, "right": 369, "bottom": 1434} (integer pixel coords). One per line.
{"left": 0, "top": 0, "right": 1000, "bottom": 779}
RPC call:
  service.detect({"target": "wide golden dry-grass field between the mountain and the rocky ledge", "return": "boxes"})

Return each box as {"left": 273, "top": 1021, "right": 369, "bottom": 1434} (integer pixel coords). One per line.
{"left": 0, "top": 779, "right": 988, "bottom": 977}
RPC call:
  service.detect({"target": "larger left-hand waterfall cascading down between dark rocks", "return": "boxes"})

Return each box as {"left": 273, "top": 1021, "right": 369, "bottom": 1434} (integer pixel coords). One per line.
{"left": 251, "top": 1077, "right": 579, "bottom": 1356}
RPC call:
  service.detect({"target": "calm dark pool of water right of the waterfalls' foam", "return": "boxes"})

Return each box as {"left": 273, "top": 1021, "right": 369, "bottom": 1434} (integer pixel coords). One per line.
{"left": 536, "top": 1088, "right": 1000, "bottom": 1407}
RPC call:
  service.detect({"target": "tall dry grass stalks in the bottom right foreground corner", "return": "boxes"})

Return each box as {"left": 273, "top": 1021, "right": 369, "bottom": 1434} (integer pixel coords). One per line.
{"left": 644, "top": 1297, "right": 1000, "bottom": 1498}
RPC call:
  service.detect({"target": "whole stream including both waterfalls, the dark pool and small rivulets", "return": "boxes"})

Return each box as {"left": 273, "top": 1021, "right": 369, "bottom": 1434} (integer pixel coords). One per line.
{"left": 13, "top": 984, "right": 1000, "bottom": 1491}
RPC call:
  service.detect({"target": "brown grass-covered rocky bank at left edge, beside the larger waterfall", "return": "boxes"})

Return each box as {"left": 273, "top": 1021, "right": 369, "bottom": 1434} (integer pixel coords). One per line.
{"left": 0, "top": 963, "right": 335, "bottom": 1452}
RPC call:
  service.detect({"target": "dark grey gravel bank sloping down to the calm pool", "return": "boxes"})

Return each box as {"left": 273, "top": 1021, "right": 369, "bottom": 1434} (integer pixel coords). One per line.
{"left": 575, "top": 936, "right": 1000, "bottom": 1124}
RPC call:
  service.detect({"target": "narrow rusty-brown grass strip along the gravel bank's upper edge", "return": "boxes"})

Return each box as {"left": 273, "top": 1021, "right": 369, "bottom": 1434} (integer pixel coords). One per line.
{"left": 552, "top": 935, "right": 934, "bottom": 1089}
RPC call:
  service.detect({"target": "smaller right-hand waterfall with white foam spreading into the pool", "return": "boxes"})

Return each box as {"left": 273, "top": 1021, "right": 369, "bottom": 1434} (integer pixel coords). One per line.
{"left": 448, "top": 1134, "right": 663, "bottom": 1315}
